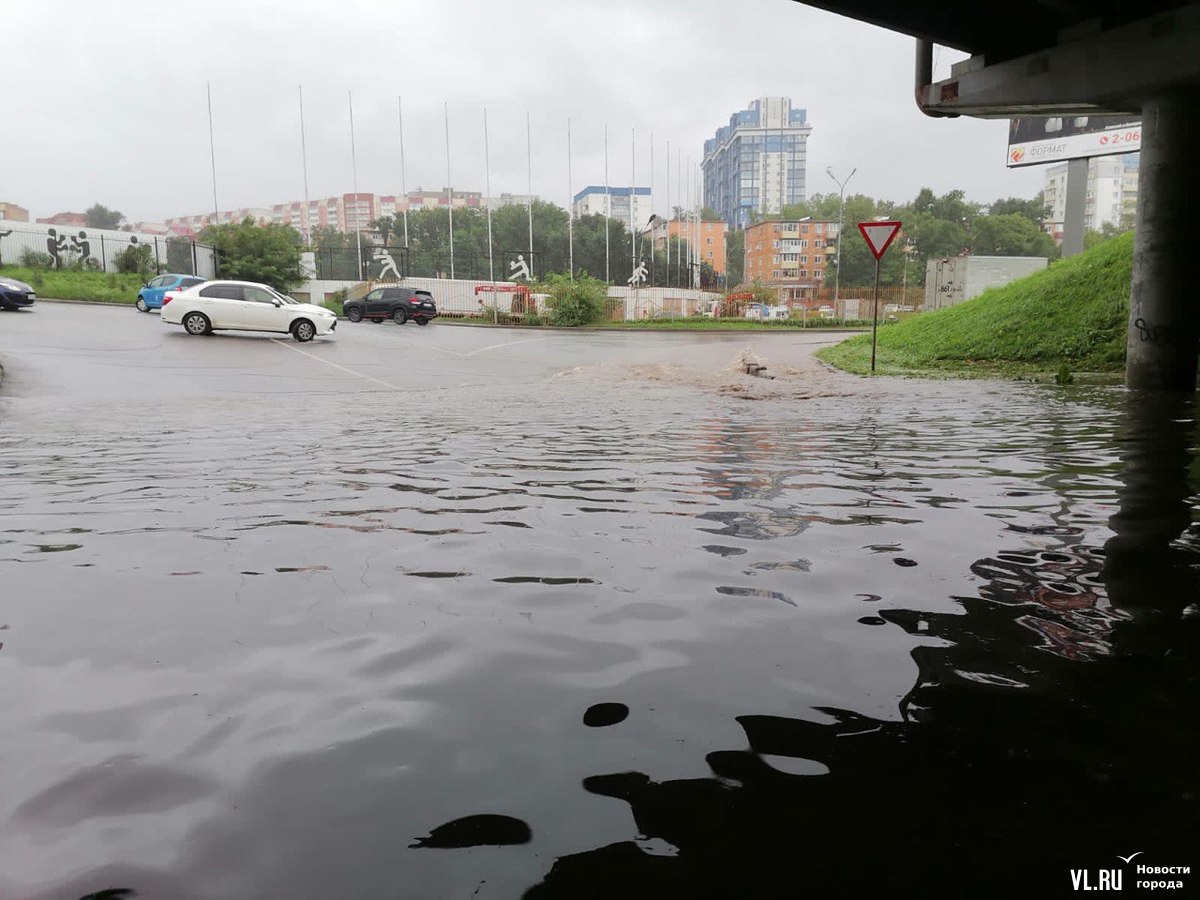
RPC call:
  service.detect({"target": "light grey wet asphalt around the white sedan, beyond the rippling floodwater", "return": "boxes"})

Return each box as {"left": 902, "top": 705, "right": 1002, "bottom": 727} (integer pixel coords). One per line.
{"left": 0, "top": 302, "right": 857, "bottom": 421}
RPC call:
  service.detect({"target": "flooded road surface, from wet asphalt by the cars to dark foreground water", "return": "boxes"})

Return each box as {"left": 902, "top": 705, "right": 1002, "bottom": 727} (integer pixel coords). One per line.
{"left": 0, "top": 304, "right": 1200, "bottom": 900}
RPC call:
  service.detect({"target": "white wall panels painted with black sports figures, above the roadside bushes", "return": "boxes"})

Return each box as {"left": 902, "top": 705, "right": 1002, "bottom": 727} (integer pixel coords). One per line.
{"left": 0, "top": 221, "right": 216, "bottom": 278}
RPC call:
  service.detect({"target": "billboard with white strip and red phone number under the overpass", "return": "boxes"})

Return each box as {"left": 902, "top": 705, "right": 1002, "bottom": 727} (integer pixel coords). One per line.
{"left": 1008, "top": 115, "right": 1141, "bottom": 169}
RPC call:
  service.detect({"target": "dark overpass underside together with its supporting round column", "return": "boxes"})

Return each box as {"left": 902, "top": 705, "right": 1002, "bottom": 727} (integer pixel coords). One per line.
{"left": 799, "top": 0, "right": 1200, "bottom": 391}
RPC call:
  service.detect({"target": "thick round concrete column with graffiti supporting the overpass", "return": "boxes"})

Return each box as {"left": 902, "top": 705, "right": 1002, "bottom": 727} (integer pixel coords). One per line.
{"left": 1126, "top": 90, "right": 1200, "bottom": 391}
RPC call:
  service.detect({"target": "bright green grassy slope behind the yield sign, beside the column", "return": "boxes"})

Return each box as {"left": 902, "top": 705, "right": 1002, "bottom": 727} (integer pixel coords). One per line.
{"left": 817, "top": 233, "right": 1133, "bottom": 378}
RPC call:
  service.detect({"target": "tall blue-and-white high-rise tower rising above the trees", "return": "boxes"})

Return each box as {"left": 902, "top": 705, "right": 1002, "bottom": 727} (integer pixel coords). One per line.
{"left": 702, "top": 97, "right": 812, "bottom": 228}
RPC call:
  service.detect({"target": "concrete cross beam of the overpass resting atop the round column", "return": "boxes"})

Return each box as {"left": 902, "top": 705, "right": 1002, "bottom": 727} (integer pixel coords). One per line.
{"left": 917, "top": 4, "right": 1200, "bottom": 119}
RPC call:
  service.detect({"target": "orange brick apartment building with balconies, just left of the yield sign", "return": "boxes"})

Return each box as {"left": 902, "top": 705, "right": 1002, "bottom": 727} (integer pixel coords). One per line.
{"left": 743, "top": 218, "right": 838, "bottom": 304}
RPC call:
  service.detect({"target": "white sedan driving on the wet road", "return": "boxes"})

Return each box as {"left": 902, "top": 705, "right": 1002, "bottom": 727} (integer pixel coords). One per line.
{"left": 162, "top": 281, "right": 337, "bottom": 343}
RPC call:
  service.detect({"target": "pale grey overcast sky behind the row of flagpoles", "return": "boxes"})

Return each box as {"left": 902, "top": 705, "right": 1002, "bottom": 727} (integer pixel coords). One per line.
{"left": 0, "top": 0, "right": 1042, "bottom": 221}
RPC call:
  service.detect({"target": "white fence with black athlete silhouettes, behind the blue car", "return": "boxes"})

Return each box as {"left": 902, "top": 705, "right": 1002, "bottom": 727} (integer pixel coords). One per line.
{"left": 0, "top": 220, "right": 217, "bottom": 278}
